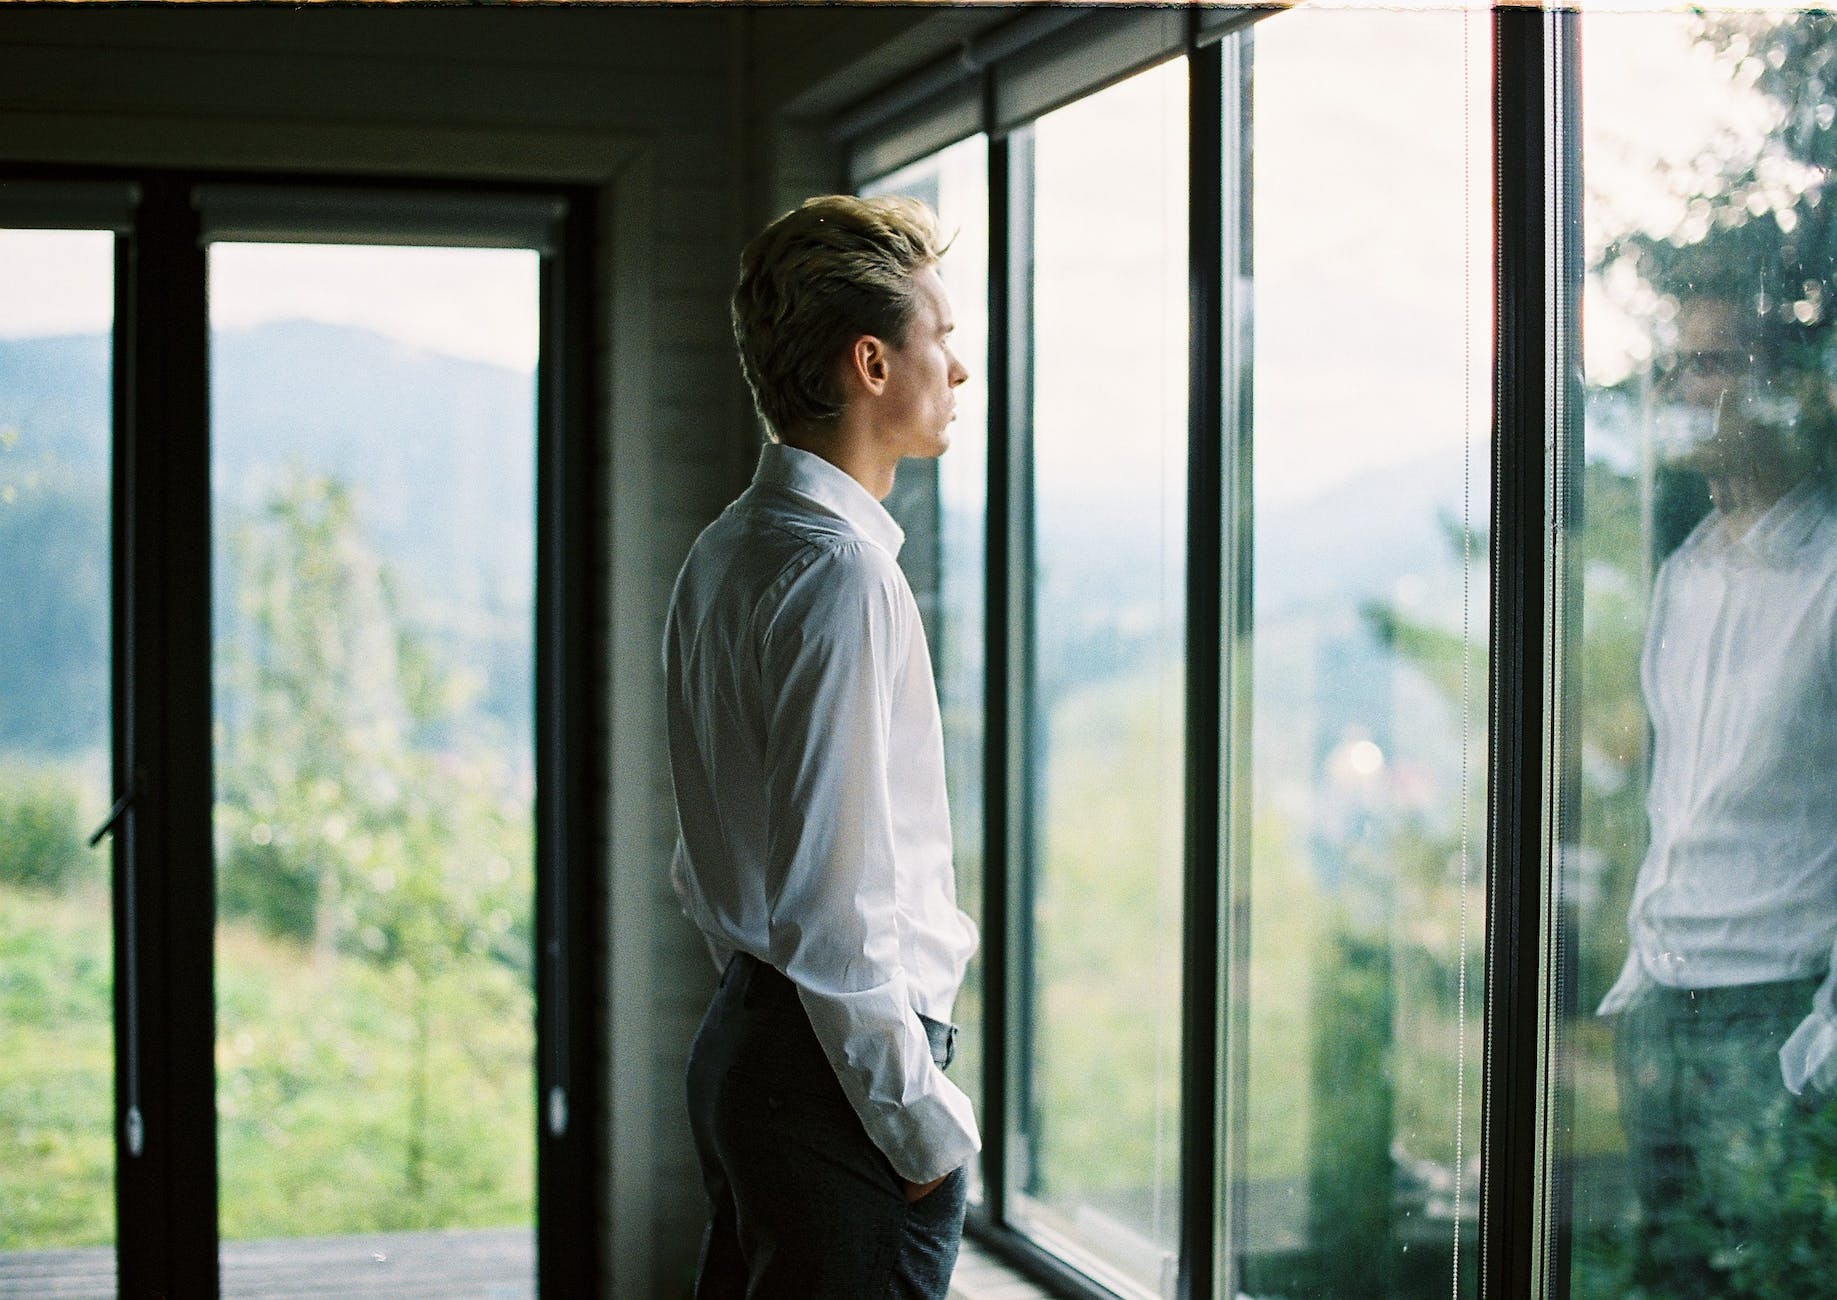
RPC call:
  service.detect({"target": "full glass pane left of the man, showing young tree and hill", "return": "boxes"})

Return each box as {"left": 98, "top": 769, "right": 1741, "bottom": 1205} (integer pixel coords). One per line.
{"left": 209, "top": 244, "right": 538, "bottom": 1294}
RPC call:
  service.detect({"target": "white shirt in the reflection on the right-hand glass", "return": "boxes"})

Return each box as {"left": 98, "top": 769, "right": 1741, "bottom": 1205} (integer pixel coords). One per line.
{"left": 1600, "top": 479, "right": 1837, "bottom": 1093}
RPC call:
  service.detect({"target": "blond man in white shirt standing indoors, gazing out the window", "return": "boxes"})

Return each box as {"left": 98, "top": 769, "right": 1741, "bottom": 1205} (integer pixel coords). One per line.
{"left": 665, "top": 196, "right": 979, "bottom": 1298}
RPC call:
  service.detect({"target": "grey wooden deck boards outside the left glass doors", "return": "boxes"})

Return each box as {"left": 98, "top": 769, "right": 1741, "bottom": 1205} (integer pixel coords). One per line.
{"left": 0, "top": 1228, "right": 536, "bottom": 1300}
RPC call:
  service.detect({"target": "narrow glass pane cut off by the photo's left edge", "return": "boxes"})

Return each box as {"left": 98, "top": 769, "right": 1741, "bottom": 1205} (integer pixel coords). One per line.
{"left": 0, "top": 230, "right": 116, "bottom": 1294}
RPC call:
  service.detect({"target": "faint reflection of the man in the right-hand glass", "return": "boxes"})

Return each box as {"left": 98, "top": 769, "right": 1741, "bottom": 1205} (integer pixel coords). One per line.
{"left": 1600, "top": 296, "right": 1837, "bottom": 1294}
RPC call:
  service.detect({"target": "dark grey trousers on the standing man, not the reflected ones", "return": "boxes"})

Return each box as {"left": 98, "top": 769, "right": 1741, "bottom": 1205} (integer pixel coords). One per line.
{"left": 689, "top": 955, "right": 966, "bottom": 1300}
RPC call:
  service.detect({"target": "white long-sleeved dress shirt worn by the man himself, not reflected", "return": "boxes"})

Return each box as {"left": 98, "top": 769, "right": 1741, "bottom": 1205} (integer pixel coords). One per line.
{"left": 663, "top": 444, "right": 981, "bottom": 1182}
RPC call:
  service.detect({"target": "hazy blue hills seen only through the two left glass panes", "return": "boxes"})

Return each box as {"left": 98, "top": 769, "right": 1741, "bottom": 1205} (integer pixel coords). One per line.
{"left": 0, "top": 321, "right": 535, "bottom": 749}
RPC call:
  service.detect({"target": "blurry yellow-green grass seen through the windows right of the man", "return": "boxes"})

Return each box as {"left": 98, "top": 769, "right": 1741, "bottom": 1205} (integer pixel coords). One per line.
{"left": 1034, "top": 678, "right": 1535, "bottom": 1197}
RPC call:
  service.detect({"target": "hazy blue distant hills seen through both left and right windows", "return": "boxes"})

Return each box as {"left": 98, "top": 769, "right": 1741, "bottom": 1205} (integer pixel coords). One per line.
{"left": 0, "top": 321, "right": 1484, "bottom": 771}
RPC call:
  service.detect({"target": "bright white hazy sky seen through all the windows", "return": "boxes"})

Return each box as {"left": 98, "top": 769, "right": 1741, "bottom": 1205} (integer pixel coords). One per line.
{"left": 0, "top": 4, "right": 1778, "bottom": 481}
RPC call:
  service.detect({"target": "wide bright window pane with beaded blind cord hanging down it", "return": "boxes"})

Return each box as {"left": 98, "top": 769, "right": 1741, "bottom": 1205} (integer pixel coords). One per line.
{"left": 1227, "top": 9, "right": 1492, "bottom": 1296}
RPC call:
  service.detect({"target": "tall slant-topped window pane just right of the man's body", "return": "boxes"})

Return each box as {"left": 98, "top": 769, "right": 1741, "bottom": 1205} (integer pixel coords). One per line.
{"left": 1010, "top": 61, "right": 1187, "bottom": 1294}
